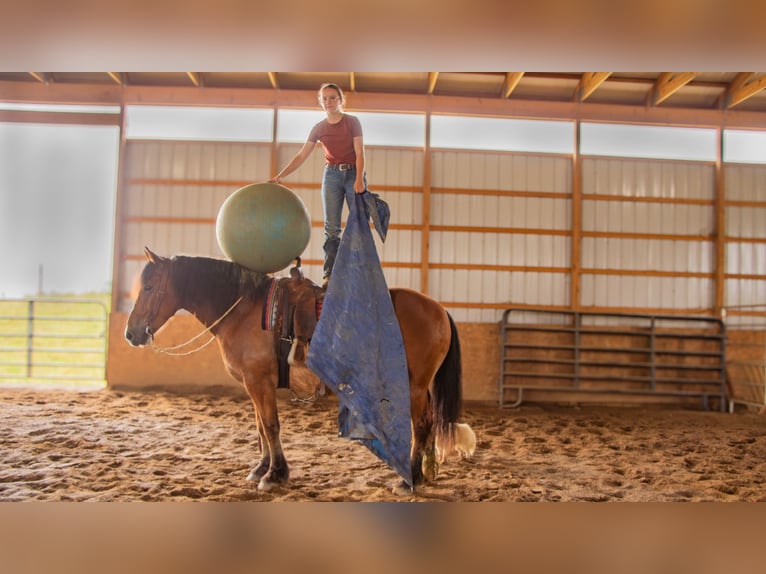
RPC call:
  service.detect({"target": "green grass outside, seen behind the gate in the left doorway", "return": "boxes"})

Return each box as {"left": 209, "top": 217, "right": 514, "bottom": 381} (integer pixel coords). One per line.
{"left": 0, "top": 293, "right": 110, "bottom": 388}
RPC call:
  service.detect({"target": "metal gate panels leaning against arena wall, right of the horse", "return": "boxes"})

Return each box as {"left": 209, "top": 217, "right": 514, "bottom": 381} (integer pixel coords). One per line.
{"left": 499, "top": 308, "right": 727, "bottom": 411}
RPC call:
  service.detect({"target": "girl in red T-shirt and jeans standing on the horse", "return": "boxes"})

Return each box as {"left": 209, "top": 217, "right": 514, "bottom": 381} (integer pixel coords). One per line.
{"left": 269, "top": 84, "right": 367, "bottom": 287}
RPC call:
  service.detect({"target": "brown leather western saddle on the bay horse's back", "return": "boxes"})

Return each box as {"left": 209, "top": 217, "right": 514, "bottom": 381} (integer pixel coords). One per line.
{"left": 261, "top": 257, "right": 324, "bottom": 388}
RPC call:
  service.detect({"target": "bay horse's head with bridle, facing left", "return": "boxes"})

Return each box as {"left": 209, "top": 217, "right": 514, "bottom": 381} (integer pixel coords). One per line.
{"left": 125, "top": 247, "right": 179, "bottom": 347}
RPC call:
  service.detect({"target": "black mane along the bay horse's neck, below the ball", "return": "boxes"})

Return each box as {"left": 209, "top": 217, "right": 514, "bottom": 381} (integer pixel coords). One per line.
{"left": 171, "top": 255, "right": 270, "bottom": 314}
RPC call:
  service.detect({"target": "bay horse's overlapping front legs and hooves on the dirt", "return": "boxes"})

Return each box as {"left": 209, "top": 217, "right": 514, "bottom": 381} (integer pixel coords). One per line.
{"left": 245, "top": 377, "right": 290, "bottom": 490}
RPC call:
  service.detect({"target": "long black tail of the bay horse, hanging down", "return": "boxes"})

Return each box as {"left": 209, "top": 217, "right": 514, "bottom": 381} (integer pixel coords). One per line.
{"left": 433, "top": 313, "right": 463, "bottom": 445}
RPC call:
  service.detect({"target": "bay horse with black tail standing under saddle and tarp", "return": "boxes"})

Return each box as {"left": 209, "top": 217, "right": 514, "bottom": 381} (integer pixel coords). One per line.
{"left": 125, "top": 248, "right": 462, "bottom": 491}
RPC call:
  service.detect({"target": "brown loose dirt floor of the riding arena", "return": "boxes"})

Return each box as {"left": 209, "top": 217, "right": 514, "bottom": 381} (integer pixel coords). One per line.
{"left": 0, "top": 389, "right": 766, "bottom": 502}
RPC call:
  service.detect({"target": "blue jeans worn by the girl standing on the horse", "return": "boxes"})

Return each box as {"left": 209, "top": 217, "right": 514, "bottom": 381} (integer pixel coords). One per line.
{"left": 322, "top": 166, "right": 367, "bottom": 277}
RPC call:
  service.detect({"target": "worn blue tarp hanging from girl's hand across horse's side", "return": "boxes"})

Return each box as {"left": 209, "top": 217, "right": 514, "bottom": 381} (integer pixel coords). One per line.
{"left": 306, "top": 194, "right": 412, "bottom": 486}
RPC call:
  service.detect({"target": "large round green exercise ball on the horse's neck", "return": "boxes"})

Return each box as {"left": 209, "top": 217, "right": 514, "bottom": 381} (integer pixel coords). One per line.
{"left": 215, "top": 183, "right": 311, "bottom": 273}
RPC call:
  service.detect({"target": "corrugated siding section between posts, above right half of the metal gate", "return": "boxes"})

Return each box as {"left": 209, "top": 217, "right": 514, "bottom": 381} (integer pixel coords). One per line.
{"left": 581, "top": 158, "right": 715, "bottom": 310}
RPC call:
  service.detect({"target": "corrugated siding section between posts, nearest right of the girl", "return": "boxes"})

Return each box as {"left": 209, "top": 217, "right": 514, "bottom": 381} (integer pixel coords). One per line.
{"left": 429, "top": 150, "right": 571, "bottom": 322}
